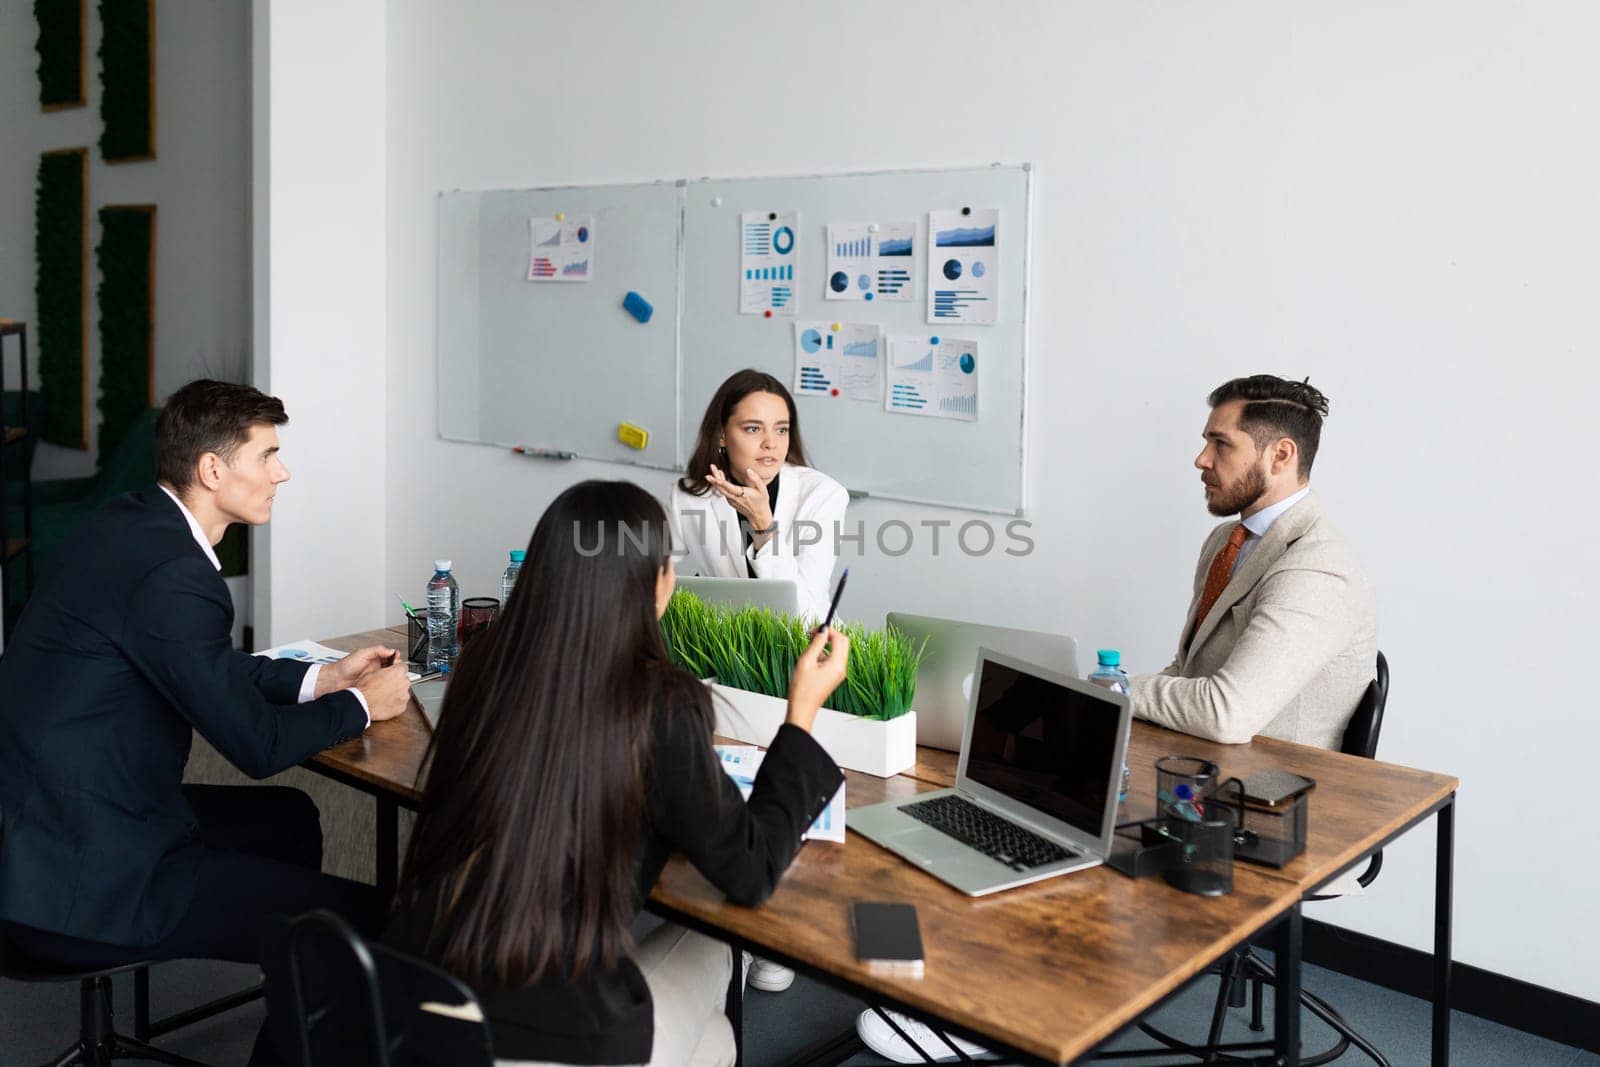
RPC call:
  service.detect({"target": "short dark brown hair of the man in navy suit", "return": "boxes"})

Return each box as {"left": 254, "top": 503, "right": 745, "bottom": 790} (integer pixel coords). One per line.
{"left": 155, "top": 378, "right": 290, "bottom": 496}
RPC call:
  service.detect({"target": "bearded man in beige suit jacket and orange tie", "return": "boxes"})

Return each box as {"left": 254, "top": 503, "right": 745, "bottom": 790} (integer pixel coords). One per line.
{"left": 1131, "top": 374, "right": 1378, "bottom": 749}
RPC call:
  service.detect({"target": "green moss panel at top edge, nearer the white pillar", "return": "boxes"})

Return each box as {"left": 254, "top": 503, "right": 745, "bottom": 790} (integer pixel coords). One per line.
{"left": 99, "top": 0, "right": 155, "bottom": 163}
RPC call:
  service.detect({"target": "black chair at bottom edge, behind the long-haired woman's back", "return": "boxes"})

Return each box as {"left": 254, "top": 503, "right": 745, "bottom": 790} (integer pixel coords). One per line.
{"left": 262, "top": 912, "right": 494, "bottom": 1067}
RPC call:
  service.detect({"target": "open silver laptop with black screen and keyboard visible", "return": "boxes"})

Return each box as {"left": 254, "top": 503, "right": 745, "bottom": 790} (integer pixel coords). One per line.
{"left": 848, "top": 648, "right": 1133, "bottom": 896}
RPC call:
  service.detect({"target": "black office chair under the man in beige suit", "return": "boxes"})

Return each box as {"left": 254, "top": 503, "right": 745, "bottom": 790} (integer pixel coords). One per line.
{"left": 1139, "top": 653, "right": 1389, "bottom": 1067}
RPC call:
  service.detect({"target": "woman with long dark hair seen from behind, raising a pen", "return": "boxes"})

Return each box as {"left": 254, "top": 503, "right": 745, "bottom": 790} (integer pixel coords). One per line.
{"left": 386, "top": 482, "right": 850, "bottom": 1064}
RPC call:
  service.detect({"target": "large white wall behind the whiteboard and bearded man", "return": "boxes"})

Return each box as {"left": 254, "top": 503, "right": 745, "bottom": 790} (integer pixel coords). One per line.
{"left": 258, "top": 0, "right": 1600, "bottom": 1000}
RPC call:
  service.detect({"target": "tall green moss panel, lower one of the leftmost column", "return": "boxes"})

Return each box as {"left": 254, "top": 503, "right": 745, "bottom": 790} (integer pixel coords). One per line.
{"left": 34, "top": 149, "right": 90, "bottom": 448}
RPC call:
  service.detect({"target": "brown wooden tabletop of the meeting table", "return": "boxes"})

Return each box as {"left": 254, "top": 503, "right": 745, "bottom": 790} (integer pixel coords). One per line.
{"left": 314, "top": 627, "right": 1456, "bottom": 1064}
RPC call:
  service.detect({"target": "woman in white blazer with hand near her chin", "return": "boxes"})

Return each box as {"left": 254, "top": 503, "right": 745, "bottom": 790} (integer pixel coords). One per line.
{"left": 672, "top": 370, "right": 850, "bottom": 621}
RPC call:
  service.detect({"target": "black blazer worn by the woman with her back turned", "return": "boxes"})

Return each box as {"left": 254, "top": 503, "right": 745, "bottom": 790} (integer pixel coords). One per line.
{"left": 384, "top": 709, "right": 843, "bottom": 1064}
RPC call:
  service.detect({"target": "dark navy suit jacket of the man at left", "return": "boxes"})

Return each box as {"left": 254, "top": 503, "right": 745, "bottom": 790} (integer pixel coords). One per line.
{"left": 0, "top": 486, "right": 366, "bottom": 947}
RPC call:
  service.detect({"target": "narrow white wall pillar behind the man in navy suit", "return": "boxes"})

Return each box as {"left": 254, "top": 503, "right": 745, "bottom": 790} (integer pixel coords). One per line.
{"left": 251, "top": 0, "right": 387, "bottom": 648}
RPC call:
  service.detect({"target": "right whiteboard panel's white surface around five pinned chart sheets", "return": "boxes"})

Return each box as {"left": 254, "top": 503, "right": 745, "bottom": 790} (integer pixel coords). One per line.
{"left": 678, "top": 165, "right": 1030, "bottom": 514}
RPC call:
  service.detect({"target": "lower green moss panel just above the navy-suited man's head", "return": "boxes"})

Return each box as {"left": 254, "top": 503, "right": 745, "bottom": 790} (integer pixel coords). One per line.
{"left": 94, "top": 203, "right": 155, "bottom": 462}
